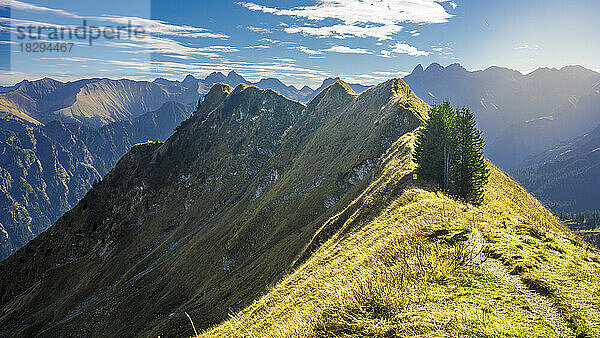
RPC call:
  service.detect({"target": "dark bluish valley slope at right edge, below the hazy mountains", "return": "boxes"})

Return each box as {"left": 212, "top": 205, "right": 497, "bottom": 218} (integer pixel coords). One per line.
{"left": 511, "top": 121, "right": 600, "bottom": 212}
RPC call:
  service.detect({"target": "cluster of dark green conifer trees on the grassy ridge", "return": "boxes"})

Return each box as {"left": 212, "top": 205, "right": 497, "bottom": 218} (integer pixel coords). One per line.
{"left": 414, "top": 101, "right": 489, "bottom": 205}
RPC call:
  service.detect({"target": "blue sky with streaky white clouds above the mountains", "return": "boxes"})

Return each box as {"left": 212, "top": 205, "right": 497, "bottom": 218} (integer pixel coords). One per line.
{"left": 0, "top": 0, "right": 600, "bottom": 88}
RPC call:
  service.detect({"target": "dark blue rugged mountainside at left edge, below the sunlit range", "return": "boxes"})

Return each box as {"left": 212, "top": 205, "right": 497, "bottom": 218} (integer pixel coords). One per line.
{"left": 0, "top": 102, "right": 192, "bottom": 259}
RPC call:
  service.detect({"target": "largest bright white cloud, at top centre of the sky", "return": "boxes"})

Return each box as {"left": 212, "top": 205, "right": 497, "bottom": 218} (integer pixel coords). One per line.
{"left": 238, "top": 0, "right": 452, "bottom": 40}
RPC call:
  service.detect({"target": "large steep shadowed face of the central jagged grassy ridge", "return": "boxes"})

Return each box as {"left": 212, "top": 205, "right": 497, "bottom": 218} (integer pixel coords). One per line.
{"left": 0, "top": 79, "right": 427, "bottom": 336}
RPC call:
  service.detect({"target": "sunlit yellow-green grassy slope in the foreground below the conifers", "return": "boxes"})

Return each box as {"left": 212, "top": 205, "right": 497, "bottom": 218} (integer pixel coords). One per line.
{"left": 202, "top": 138, "right": 600, "bottom": 337}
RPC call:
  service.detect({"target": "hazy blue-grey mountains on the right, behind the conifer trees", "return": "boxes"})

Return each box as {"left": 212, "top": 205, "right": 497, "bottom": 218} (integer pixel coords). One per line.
{"left": 404, "top": 63, "right": 600, "bottom": 168}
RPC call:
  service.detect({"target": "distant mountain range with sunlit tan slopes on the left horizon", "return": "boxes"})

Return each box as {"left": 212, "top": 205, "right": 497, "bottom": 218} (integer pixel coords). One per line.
{"left": 0, "top": 71, "right": 369, "bottom": 130}
